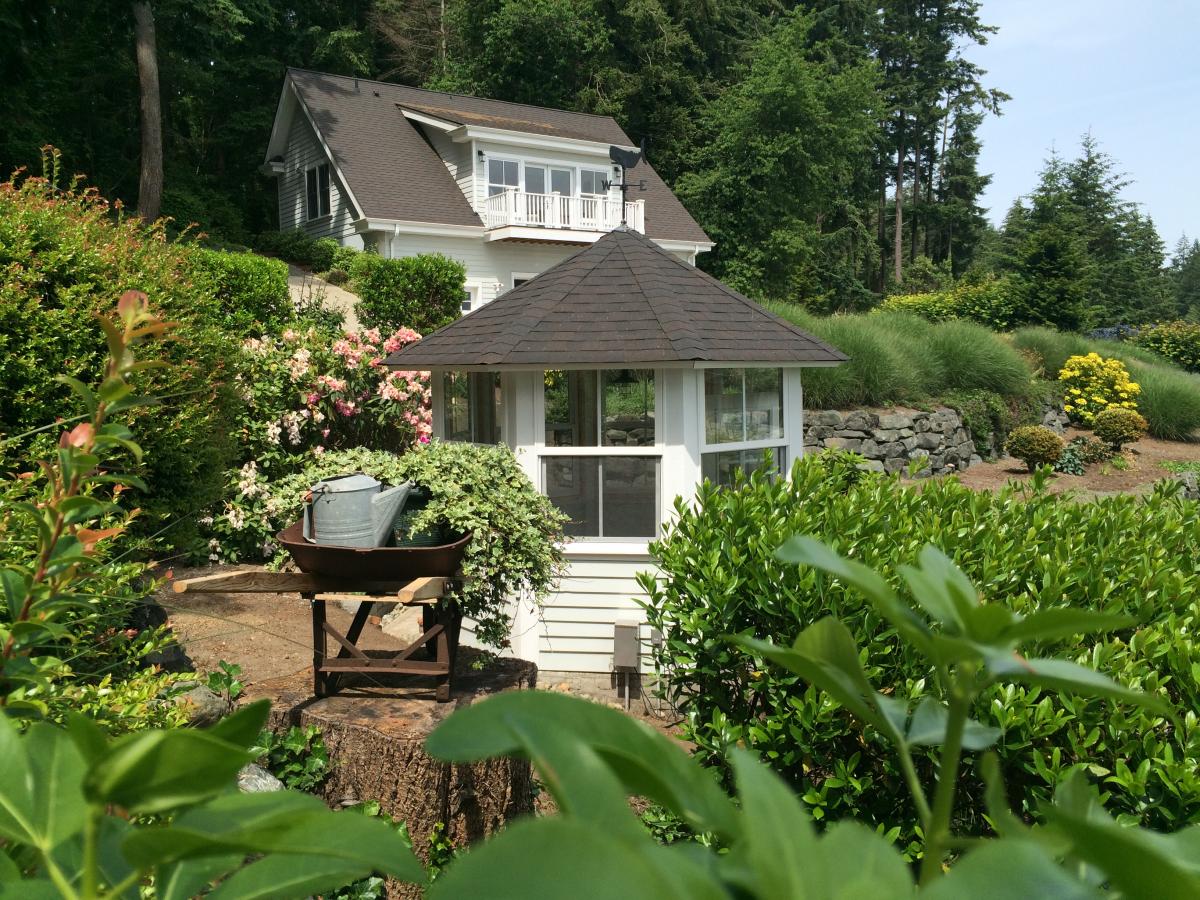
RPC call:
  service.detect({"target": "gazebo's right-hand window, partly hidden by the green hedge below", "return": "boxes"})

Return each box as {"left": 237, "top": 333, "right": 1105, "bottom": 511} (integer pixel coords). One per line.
{"left": 700, "top": 368, "right": 787, "bottom": 485}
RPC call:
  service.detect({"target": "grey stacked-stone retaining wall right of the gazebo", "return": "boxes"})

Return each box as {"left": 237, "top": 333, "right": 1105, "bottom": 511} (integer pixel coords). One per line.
{"left": 804, "top": 407, "right": 983, "bottom": 475}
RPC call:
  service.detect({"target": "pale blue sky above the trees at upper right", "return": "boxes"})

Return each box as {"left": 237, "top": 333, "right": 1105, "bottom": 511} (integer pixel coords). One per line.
{"left": 967, "top": 0, "right": 1200, "bottom": 252}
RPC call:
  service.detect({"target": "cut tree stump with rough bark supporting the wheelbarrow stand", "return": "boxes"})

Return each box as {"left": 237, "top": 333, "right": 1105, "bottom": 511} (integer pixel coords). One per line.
{"left": 246, "top": 647, "right": 538, "bottom": 898}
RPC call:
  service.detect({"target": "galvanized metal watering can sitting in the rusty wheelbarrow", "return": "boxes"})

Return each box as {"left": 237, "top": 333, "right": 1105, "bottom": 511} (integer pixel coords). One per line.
{"left": 304, "top": 472, "right": 413, "bottom": 547}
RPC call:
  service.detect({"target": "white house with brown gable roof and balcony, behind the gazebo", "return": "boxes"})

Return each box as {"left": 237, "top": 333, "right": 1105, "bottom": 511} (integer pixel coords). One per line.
{"left": 263, "top": 68, "right": 713, "bottom": 311}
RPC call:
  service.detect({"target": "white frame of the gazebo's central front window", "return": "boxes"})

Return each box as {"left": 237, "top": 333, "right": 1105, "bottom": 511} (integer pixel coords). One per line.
{"left": 533, "top": 366, "right": 666, "bottom": 553}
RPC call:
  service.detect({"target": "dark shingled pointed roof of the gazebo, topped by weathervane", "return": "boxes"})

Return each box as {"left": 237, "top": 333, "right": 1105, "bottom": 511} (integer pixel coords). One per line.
{"left": 386, "top": 229, "right": 846, "bottom": 370}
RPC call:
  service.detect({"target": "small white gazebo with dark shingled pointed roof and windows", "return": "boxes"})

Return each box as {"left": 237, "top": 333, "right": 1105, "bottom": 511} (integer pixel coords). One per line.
{"left": 386, "top": 228, "right": 846, "bottom": 672}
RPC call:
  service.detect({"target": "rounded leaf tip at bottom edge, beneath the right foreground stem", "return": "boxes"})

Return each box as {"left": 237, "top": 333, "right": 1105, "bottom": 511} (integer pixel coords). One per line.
{"left": 919, "top": 840, "right": 1099, "bottom": 900}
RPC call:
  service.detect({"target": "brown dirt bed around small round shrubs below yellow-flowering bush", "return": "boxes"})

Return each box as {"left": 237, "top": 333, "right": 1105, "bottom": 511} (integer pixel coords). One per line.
{"left": 956, "top": 431, "right": 1200, "bottom": 497}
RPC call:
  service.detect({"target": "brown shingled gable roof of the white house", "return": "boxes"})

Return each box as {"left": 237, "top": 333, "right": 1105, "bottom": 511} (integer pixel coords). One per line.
{"left": 268, "top": 68, "right": 709, "bottom": 242}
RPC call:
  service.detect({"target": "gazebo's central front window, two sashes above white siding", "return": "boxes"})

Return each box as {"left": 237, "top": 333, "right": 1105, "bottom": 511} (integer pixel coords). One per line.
{"left": 541, "top": 368, "right": 662, "bottom": 540}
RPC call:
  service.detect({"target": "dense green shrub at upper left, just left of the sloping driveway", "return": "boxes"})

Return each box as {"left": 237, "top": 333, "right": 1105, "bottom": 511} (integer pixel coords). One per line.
{"left": 190, "top": 248, "right": 293, "bottom": 335}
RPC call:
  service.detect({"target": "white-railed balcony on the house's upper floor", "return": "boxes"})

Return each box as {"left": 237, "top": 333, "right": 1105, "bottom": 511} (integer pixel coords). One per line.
{"left": 484, "top": 188, "right": 646, "bottom": 244}
